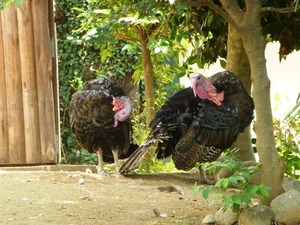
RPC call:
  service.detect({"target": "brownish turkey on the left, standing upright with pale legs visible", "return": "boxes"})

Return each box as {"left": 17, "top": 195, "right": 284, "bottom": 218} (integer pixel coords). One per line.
{"left": 70, "top": 77, "right": 138, "bottom": 174}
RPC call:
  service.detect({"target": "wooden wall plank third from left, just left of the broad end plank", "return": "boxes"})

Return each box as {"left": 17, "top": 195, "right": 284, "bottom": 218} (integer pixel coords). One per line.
{"left": 17, "top": 1, "right": 41, "bottom": 163}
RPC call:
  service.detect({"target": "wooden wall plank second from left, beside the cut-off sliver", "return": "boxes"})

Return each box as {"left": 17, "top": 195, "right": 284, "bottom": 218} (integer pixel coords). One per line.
{"left": 1, "top": 4, "right": 26, "bottom": 164}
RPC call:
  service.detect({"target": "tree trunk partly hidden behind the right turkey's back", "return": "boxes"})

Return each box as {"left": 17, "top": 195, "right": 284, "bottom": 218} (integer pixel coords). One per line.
{"left": 226, "top": 24, "right": 255, "bottom": 161}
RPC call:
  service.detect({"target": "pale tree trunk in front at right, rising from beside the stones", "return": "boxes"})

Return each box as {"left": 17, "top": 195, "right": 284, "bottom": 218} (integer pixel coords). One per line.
{"left": 240, "top": 3, "right": 284, "bottom": 205}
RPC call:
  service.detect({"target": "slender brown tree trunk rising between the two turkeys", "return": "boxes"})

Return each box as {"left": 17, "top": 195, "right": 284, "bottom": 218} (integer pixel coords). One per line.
{"left": 138, "top": 27, "right": 154, "bottom": 127}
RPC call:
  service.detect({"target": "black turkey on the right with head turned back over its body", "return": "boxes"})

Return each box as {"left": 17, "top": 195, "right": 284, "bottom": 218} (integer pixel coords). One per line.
{"left": 120, "top": 71, "right": 254, "bottom": 183}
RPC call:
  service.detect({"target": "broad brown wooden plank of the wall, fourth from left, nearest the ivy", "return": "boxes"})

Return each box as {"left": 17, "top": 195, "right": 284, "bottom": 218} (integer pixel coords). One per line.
{"left": 31, "top": 0, "right": 58, "bottom": 163}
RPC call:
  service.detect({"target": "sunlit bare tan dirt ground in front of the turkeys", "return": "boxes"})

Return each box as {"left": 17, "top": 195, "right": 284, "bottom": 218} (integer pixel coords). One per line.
{"left": 0, "top": 167, "right": 217, "bottom": 225}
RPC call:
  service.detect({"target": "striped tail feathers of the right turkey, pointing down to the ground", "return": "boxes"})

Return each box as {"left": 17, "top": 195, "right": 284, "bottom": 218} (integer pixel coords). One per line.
{"left": 119, "top": 139, "right": 157, "bottom": 174}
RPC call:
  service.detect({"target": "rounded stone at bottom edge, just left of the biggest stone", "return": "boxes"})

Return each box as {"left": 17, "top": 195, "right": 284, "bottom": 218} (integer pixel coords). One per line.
{"left": 238, "top": 205, "right": 274, "bottom": 225}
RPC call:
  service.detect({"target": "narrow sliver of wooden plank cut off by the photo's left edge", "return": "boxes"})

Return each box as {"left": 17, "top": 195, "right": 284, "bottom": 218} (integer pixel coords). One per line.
{"left": 0, "top": 11, "right": 9, "bottom": 164}
